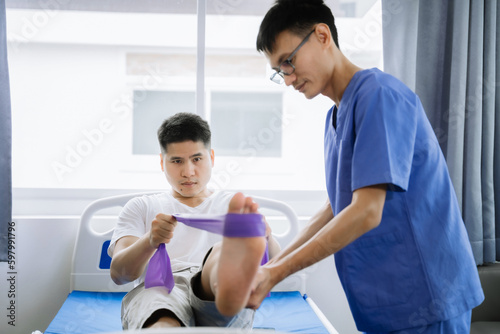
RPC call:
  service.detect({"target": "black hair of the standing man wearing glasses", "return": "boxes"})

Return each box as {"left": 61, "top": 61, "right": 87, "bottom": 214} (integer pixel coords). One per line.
{"left": 257, "top": 0, "right": 339, "bottom": 53}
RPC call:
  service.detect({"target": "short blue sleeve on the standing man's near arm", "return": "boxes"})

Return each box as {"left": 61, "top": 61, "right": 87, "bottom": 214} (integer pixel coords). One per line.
{"left": 352, "top": 86, "right": 418, "bottom": 191}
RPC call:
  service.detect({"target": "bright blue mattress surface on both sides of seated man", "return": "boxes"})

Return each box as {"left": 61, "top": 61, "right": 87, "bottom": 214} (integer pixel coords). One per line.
{"left": 45, "top": 291, "right": 328, "bottom": 334}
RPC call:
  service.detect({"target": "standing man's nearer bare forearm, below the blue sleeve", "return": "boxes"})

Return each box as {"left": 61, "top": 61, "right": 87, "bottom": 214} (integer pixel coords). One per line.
{"left": 266, "top": 186, "right": 386, "bottom": 285}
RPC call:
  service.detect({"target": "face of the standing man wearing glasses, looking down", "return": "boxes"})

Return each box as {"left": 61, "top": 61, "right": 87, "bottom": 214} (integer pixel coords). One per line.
{"left": 265, "top": 29, "right": 324, "bottom": 99}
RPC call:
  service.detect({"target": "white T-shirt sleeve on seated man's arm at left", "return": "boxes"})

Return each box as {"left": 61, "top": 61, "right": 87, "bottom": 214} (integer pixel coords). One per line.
{"left": 108, "top": 197, "right": 147, "bottom": 257}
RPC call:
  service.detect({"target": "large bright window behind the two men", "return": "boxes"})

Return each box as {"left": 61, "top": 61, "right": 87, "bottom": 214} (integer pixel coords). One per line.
{"left": 6, "top": 0, "right": 382, "bottom": 190}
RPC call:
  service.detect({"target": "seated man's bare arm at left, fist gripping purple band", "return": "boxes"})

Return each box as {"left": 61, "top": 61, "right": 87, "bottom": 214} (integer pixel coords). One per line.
{"left": 110, "top": 214, "right": 177, "bottom": 284}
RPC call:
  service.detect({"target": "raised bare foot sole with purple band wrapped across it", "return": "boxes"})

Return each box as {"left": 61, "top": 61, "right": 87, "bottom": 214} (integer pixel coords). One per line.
{"left": 215, "top": 193, "right": 266, "bottom": 316}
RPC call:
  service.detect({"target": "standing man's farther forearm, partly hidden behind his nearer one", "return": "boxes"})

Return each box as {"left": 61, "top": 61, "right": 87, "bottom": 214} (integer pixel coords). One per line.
{"left": 270, "top": 201, "right": 333, "bottom": 263}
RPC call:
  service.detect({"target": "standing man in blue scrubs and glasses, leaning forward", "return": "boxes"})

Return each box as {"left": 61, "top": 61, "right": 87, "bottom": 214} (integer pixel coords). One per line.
{"left": 249, "top": 0, "right": 484, "bottom": 334}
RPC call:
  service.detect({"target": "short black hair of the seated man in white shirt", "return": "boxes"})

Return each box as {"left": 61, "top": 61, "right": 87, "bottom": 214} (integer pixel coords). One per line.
{"left": 158, "top": 112, "right": 212, "bottom": 153}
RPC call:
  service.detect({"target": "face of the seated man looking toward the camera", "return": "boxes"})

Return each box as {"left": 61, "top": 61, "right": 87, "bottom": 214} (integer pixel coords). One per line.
{"left": 161, "top": 141, "right": 214, "bottom": 197}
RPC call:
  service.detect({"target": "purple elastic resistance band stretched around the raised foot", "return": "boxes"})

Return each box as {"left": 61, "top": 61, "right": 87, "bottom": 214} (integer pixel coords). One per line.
{"left": 144, "top": 213, "right": 269, "bottom": 293}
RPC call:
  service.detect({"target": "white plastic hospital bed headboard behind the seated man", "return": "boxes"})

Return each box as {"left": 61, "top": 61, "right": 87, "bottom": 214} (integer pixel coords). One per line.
{"left": 71, "top": 192, "right": 305, "bottom": 294}
